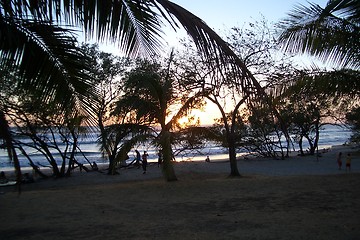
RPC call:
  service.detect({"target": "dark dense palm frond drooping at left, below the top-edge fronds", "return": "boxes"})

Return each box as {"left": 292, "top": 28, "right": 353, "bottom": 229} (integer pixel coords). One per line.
{"left": 0, "top": 18, "right": 96, "bottom": 117}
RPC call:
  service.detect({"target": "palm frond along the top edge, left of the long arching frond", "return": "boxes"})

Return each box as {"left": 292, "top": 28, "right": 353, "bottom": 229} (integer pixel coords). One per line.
{"left": 0, "top": 0, "right": 162, "bottom": 56}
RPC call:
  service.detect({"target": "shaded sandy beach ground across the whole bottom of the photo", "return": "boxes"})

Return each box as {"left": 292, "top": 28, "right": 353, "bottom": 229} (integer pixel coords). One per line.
{"left": 0, "top": 145, "right": 360, "bottom": 240}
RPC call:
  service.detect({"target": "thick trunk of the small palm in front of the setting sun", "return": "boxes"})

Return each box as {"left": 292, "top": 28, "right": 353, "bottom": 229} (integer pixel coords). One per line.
{"left": 160, "top": 131, "right": 177, "bottom": 182}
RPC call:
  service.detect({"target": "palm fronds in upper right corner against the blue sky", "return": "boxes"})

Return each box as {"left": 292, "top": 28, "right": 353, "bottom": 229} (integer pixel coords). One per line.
{"left": 279, "top": 0, "right": 360, "bottom": 68}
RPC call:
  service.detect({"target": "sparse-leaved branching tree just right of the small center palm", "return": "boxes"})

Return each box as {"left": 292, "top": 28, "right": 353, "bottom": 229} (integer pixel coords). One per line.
{"left": 173, "top": 20, "right": 300, "bottom": 172}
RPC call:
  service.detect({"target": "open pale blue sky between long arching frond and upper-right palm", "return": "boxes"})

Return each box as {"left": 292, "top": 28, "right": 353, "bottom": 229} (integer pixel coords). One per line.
{"left": 162, "top": 0, "right": 328, "bottom": 47}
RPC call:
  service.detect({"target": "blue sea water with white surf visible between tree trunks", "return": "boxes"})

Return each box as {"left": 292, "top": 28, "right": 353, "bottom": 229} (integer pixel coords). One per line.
{"left": 0, "top": 125, "right": 351, "bottom": 171}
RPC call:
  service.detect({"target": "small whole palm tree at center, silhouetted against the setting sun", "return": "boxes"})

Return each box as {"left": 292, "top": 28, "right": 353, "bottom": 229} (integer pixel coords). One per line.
{"left": 114, "top": 60, "right": 202, "bottom": 181}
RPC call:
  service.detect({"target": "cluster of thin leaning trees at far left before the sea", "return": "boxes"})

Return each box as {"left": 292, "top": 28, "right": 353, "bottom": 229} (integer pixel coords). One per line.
{"left": 2, "top": 98, "right": 91, "bottom": 177}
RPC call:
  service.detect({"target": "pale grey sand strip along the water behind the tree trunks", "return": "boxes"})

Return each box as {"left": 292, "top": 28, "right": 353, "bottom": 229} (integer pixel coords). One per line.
{"left": 0, "top": 142, "right": 360, "bottom": 190}
